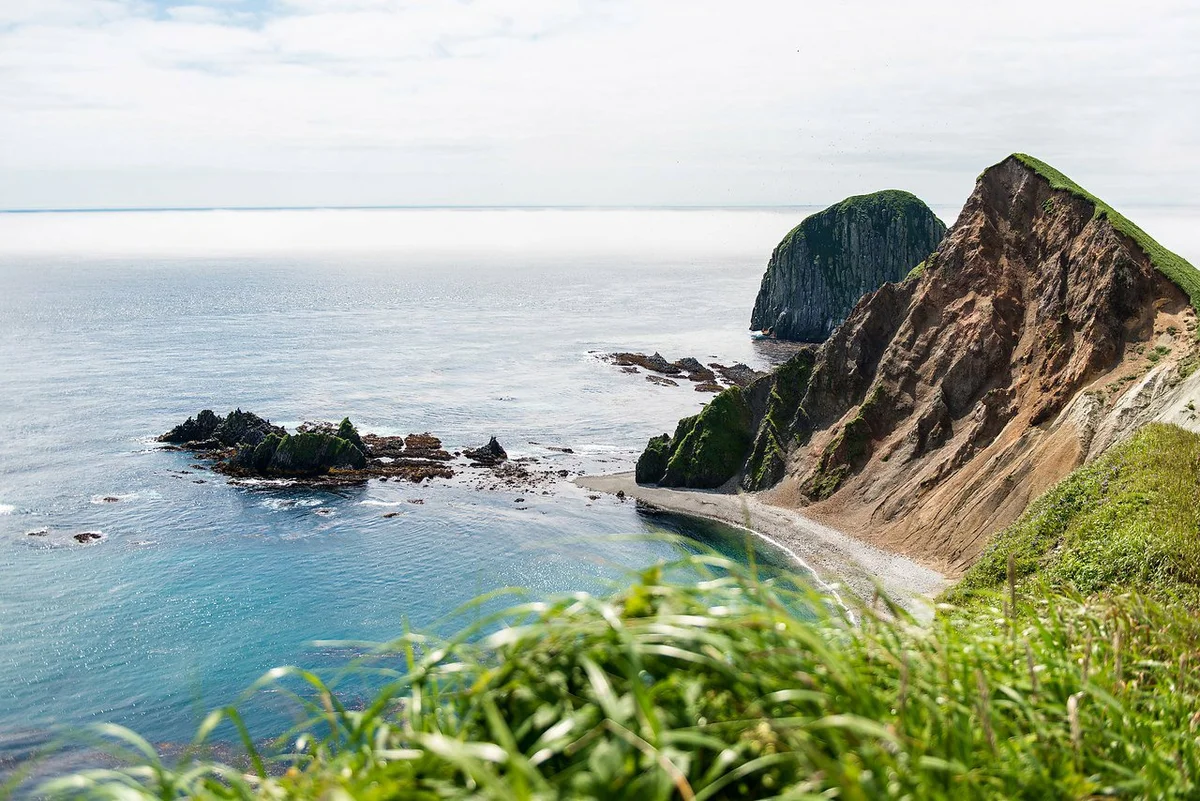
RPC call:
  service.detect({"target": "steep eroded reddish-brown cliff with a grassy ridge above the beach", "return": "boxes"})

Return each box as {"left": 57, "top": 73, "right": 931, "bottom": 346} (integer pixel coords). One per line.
{"left": 643, "top": 156, "right": 1200, "bottom": 573}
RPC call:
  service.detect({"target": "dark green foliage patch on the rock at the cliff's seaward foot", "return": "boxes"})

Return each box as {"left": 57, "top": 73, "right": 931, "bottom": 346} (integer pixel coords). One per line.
{"left": 660, "top": 386, "right": 754, "bottom": 489}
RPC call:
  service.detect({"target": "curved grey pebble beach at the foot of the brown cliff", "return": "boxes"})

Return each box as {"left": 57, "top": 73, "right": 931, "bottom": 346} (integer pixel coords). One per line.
{"left": 575, "top": 472, "right": 950, "bottom": 621}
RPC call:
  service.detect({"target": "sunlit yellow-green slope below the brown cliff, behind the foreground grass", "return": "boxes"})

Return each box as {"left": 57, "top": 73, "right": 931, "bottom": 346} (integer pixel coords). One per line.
{"left": 947, "top": 424, "right": 1200, "bottom": 603}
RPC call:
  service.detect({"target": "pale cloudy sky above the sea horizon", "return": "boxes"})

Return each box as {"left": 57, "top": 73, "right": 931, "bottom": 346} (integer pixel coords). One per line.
{"left": 0, "top": 0, "right": 1200, "bottom": 209}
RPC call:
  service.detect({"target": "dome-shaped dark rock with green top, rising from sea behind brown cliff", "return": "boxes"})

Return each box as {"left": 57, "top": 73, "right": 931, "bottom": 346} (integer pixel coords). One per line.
{"left": 750, "top": 191, "right": 946, "bottom": 342}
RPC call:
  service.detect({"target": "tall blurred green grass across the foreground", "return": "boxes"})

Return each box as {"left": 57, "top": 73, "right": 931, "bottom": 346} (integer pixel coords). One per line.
{"left": 25, "top": 558, "right": 1200, "bottom": 801}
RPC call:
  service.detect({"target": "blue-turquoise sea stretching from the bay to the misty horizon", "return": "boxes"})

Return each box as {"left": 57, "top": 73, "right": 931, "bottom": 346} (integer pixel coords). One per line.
{"left": 0, "top": 207, "right": 1200, "bottom": 766}
